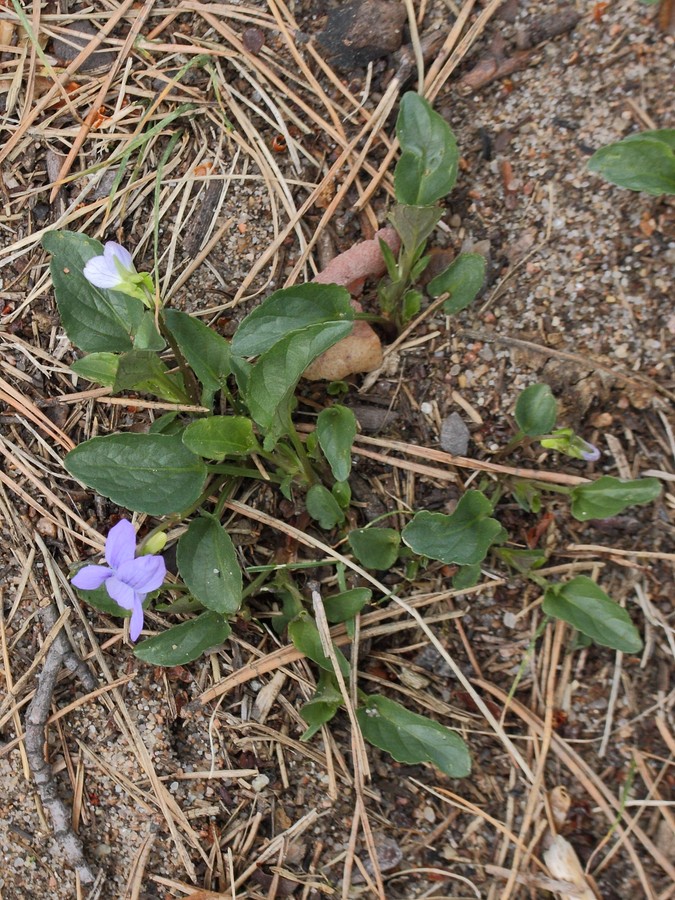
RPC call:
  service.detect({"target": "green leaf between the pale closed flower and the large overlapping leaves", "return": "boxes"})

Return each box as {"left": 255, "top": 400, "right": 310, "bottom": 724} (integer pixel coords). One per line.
{"left": 163, "top": 309, "right": 232, "bottom": 406}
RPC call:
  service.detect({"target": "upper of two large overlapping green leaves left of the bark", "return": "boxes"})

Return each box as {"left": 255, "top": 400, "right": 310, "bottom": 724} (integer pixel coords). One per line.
{"left": 232, "top": 284, "right": 354, "bottom": 360}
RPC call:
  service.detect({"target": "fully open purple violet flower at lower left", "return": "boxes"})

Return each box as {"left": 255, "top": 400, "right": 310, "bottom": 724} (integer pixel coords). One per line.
{"left": 70, "top": 519, "right": 166, "bottom": 641}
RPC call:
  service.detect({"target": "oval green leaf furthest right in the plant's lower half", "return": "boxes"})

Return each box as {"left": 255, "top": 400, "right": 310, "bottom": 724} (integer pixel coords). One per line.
{"left": 542, "top": 575, "right": 642, "bottom": 653}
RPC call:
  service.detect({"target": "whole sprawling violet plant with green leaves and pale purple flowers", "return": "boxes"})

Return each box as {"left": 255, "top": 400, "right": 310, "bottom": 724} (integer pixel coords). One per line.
{"left": 44, "top": 94, "right": 660, "bottom": 777}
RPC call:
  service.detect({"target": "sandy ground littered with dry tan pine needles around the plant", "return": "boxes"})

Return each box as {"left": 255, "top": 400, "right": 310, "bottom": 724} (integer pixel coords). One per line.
{"left": 0, "top": 0, "right": 675, "bottom": 900}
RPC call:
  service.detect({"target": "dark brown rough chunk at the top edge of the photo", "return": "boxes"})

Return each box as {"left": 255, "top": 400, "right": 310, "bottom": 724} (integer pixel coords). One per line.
{"left": 316, "top": 0, "right": 406, "bottom": 68}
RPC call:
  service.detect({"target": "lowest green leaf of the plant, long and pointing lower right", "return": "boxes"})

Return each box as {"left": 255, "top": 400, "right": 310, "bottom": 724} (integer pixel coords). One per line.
{"left": 356, "top": 695, "right": 471, "bottom": 778}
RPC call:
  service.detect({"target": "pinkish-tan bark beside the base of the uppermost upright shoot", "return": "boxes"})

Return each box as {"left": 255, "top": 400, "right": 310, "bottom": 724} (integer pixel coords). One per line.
{"left": 303, "top": 228, "right": 400, "bottom": 381}
